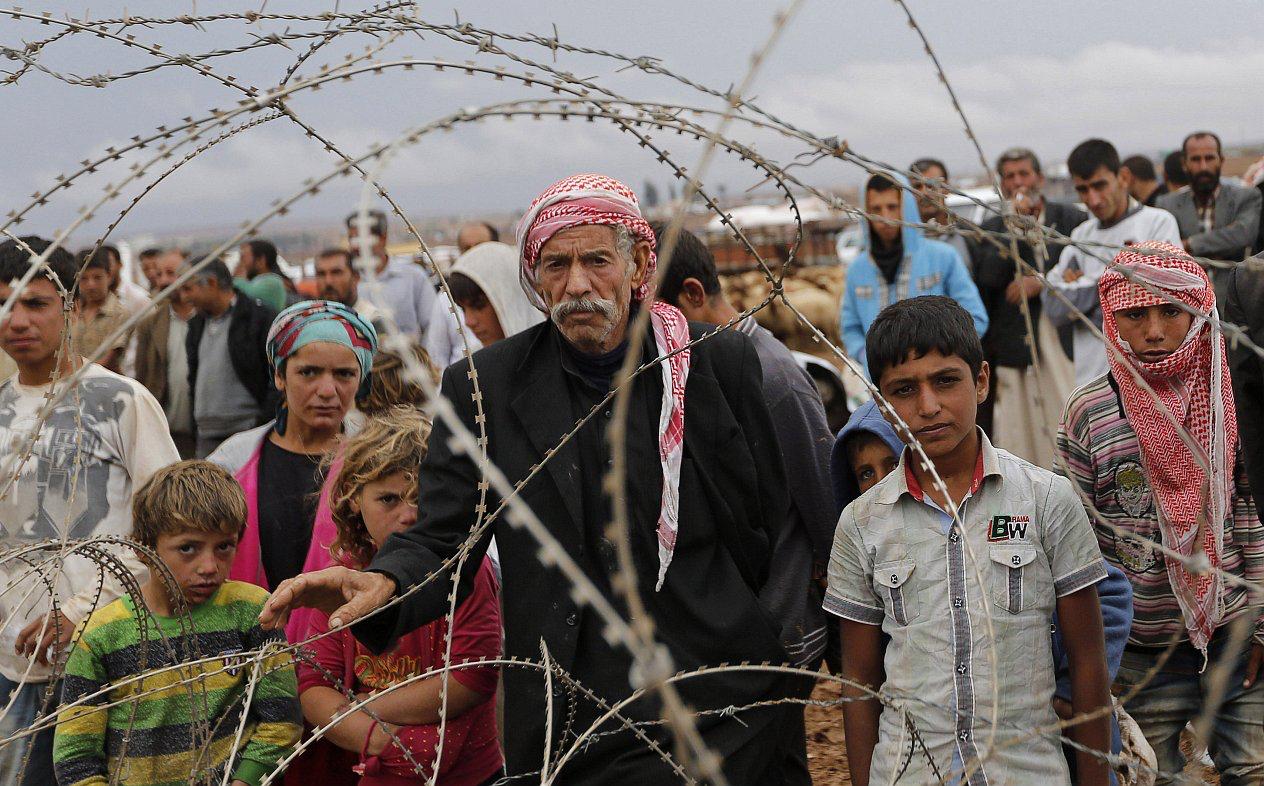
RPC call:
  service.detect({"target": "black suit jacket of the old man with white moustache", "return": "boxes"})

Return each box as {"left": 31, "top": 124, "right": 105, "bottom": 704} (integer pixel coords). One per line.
{"left": 354, "top": 322, "right": 789, "bottom": 786}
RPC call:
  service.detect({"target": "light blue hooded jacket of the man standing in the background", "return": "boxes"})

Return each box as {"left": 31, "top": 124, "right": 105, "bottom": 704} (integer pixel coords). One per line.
{"left": 838, "top": 174, "right": 987, "bottom": 373}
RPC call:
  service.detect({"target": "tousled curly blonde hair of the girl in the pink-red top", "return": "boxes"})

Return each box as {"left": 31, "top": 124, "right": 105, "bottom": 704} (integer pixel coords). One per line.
{"left": 329, "top": 407, "right": 430, "bottom": 566}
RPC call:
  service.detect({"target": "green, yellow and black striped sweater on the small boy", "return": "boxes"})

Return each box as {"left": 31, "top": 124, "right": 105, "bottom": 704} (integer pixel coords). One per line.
{"left": 53, "top": 581, "right": 302, "bottom": 786}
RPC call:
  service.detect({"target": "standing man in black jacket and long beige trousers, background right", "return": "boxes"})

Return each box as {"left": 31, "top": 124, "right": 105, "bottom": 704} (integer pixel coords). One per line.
{"left": 975, "top": 148, "right": 1088, "bottom": 469}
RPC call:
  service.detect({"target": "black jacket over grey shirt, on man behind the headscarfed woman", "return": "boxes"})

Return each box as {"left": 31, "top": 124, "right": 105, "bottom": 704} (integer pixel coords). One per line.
{"left": 185, "top": 292, "right": 277, "bottom": 430}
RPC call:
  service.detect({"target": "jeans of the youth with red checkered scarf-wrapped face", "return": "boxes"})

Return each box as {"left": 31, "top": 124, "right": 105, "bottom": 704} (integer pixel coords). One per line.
{"left": 1116, "top": 626, "right": 1264, "bottom": 786}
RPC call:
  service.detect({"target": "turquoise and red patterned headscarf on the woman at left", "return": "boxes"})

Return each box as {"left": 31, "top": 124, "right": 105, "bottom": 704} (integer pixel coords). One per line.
{"left": 267, "top": 301, "right": 378, "bottom": 435}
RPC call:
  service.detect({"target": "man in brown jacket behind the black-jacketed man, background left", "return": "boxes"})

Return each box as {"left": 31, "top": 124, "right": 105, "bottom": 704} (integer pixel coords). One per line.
{"left": 137, "top": 253, "right": 196, "bottom": 459}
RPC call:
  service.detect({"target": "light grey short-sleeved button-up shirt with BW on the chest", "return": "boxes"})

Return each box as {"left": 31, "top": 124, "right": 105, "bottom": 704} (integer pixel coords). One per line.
{"left": 824, "top": 432, "right": 1106, "bottom": 786}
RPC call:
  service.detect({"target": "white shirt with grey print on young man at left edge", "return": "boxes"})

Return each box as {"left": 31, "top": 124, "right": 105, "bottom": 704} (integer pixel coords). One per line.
{"left": 0, "top": 364, "right": 179, "bottom": 682}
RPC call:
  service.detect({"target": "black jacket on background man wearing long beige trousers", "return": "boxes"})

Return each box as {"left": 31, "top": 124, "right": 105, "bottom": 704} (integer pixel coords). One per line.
{"left": 975, "top": 200, "right": 1088, "bottom": 369}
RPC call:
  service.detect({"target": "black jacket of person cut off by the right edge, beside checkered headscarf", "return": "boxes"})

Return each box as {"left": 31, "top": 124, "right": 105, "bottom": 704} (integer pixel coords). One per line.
{"left": 1222, "top": 255, "right": 1264, "bottom": 505}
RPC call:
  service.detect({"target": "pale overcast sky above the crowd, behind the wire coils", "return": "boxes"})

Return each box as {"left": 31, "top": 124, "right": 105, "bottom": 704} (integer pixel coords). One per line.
{"left": 7, "top": 0, "right": 1264, "bottom": 241}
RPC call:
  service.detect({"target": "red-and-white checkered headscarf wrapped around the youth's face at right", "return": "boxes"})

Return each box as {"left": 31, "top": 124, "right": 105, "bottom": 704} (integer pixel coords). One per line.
{"left": 1097, "top": 241, "right": 1237, "bottom": 652}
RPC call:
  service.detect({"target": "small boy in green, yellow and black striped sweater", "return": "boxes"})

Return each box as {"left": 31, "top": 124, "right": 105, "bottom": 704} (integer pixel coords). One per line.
{"left": 53, "top": 461, "right": 301, "bottom": 786}
